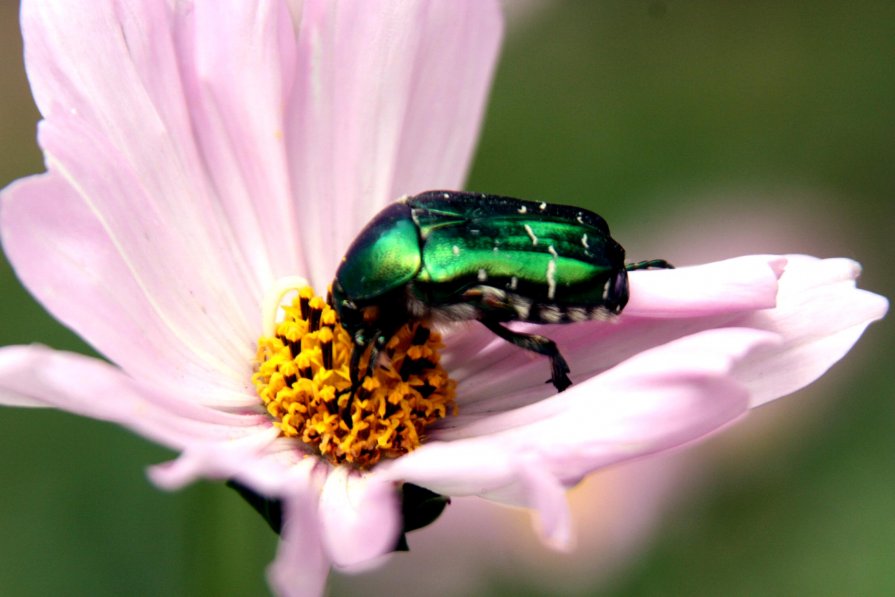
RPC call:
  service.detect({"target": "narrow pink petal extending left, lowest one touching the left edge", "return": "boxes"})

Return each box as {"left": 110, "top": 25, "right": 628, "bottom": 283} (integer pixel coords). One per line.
{"left": 0, "top": 346, "right": 316, "bottom": 496}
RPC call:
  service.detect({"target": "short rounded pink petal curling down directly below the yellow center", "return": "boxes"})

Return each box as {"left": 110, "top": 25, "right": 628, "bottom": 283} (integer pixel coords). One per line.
{"left": 319, "top": 467, "right": 401, "bottom": 566}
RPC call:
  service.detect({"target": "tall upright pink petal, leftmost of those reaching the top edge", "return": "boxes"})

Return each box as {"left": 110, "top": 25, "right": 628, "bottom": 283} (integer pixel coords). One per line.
{"left": 14, "top": 1, "right": 261, "bottom": 378}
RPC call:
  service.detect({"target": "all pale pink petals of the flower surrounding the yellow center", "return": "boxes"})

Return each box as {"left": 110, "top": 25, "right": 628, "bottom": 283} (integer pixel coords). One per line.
{"left": 0, "top": 0, "right": 887, "bottom": 595}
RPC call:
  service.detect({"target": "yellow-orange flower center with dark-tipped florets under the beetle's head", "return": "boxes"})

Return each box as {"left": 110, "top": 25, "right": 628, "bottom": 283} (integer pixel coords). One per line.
{"left": 252, "top": 287, "right": 457, "bottom": 468}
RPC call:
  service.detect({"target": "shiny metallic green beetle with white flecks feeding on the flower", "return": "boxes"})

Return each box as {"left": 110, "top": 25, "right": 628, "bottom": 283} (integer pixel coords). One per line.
{"left": 331, "top": 191, "right": 672, "bottom": 394}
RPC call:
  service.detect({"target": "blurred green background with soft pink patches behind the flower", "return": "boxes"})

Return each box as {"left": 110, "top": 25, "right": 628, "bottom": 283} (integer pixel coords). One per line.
{"left": 0, "top": 0, "right": 895, "bottom": 595}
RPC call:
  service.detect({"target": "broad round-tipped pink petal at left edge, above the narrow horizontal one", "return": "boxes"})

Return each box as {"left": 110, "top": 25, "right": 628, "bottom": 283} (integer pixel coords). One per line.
{"left": 0, "top": 173, "right": 256, "bottom": 406}
